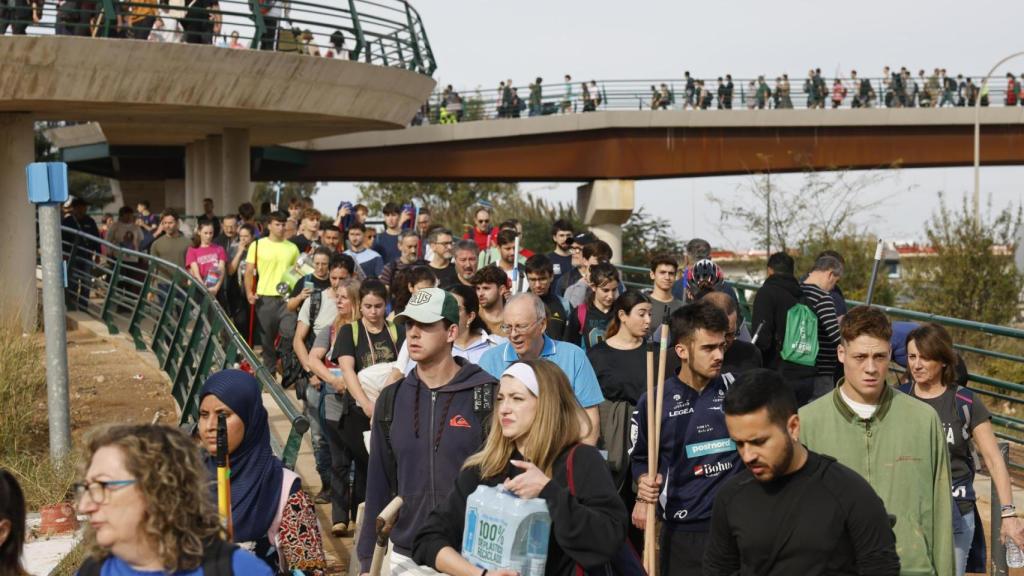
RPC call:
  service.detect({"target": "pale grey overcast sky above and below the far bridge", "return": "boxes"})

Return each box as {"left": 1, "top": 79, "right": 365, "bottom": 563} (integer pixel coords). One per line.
{"left": 316, "top": 0, "right": 1024, "bottom": 249}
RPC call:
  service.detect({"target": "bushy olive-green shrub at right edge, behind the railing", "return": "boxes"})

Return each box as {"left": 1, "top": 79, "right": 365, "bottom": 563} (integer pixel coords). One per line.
{"left": 907, "top": 193, "right": 1024, "bottom": 324}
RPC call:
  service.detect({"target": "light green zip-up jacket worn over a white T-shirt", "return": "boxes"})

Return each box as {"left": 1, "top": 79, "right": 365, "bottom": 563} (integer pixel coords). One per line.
{"left": 800, "top": 381, "right": 954, "bottom": 576}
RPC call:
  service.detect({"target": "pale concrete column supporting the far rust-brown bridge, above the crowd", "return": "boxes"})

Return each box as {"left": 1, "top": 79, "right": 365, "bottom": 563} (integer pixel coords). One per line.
{"left": 577, "top": 180, "right": 636, "bottom": 264}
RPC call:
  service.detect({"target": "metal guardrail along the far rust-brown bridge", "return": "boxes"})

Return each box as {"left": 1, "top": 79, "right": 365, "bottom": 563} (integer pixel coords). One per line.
{"left": 424, "top": 76, "right": 1019, "bottom": 123}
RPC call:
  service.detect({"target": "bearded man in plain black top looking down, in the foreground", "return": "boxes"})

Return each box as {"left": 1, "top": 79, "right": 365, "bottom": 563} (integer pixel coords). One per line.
{"left": 703, "top": 369, "right": 900, "bottom": 576}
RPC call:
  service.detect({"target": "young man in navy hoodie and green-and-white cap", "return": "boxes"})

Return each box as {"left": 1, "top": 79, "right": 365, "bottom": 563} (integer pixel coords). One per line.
{"left": 356, "top": 288, "right": 498, "bottom": 574}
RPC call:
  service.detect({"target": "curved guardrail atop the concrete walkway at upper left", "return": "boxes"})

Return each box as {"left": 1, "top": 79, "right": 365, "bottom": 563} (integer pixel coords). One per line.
{"left": 0, "top": 0, "right": 437, "bottom": 76}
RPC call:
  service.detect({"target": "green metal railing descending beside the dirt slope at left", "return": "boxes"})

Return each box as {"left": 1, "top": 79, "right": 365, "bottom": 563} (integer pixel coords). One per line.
{"left": 62, "top": 228, "right": 309, "bottom": 468}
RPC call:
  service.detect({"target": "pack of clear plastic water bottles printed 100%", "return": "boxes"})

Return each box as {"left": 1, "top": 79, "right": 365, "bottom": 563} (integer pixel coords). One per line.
{"left": 462, "top": 486, "right": 551, "bottom": 576}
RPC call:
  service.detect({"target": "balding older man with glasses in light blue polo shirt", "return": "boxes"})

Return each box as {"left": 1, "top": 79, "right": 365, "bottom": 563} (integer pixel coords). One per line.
{"left": 480, "top": 292, "right": 604, "bottom": 446}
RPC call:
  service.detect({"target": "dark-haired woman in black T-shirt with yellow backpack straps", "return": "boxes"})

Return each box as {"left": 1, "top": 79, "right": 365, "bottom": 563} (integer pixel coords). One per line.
{"left": 331, "top": 279, "right": 403, "bottom": 520}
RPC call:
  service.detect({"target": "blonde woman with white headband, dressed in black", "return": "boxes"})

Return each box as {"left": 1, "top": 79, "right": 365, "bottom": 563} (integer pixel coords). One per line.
{"left": 413, "top": 360, "right": 628, "bottom": 576}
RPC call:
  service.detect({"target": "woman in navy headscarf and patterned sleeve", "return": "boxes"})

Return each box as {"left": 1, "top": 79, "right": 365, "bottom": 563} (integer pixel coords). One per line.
{"left": 199, "top": 370, "right": 327, "bottom": 576}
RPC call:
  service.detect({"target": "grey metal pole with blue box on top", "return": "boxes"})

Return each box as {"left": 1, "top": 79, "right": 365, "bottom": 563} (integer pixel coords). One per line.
{"left": 25, "top": 162, "right": 71, "bottom": 463}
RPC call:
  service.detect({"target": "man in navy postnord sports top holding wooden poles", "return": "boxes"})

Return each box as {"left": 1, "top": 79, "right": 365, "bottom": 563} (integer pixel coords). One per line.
{"left": 630, "top": 300, "right": 742, "bottom": 576}
